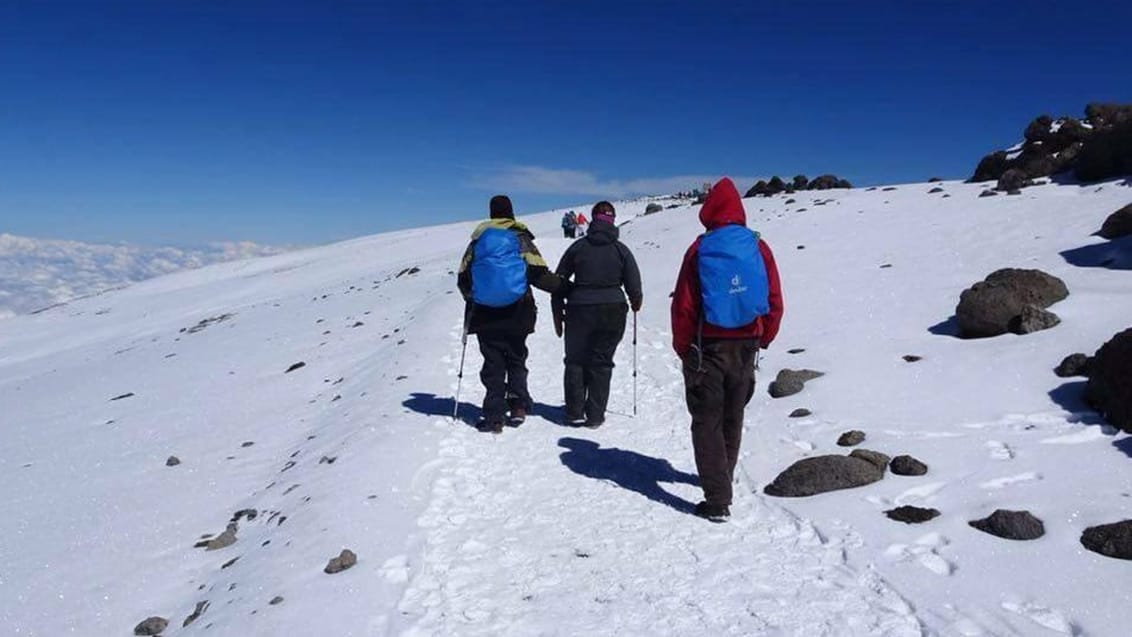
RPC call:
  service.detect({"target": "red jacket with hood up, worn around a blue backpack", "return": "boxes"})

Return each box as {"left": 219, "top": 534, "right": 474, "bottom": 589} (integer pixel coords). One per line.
{"left": 672, "top": 177, "right": 782, "bottom": 358}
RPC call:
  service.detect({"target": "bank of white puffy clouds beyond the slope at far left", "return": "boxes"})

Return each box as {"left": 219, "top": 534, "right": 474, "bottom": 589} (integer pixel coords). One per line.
{"left": 0, "top": 234, "right": 283, "bottom": 319}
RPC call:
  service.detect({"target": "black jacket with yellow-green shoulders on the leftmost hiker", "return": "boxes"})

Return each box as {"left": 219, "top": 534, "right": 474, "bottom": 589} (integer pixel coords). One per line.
{"left": 456, "top": 218, "right": 563, "bottom": 334}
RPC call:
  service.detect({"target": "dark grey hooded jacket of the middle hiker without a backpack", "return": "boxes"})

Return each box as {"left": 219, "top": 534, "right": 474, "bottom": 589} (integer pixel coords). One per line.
{"left": 554, "top": 221, "right": 642, "bottom": 312}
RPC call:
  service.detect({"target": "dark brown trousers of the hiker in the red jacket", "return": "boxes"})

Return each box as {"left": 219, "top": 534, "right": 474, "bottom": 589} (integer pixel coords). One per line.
{"left": 684, "top": 338, "right": 758, "bottom": 506}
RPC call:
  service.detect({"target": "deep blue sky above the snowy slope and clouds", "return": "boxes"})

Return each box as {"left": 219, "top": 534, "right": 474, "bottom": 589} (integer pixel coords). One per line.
{"left": 0, "top": 0, "right": 1132, "bottom": 244}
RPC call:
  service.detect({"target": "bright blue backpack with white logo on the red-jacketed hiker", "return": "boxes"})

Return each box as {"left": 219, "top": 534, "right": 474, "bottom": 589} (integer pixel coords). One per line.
{"left": 700, "top": 224, "right": 770, "bottom": 329}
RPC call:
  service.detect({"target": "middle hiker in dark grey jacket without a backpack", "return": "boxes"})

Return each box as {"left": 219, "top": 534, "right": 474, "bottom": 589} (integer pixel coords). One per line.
{"left": 550, "top": 201, "right": 642, "bottom": 428}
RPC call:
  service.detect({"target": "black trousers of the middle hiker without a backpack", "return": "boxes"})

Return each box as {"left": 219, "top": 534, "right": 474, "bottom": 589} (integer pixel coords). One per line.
{"left": 563, "top": 303, "right": 628, "bottom": 423}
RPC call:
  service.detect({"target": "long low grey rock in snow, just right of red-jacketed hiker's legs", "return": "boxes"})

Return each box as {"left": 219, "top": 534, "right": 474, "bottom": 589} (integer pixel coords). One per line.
{"left": 763, "top": 449, "right": 889, "bottom": 498}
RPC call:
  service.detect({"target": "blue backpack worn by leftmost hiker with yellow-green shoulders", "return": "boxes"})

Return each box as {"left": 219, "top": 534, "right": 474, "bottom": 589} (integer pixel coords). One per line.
{"left": 472, "top": 227, "right": 526, "bottom": 308}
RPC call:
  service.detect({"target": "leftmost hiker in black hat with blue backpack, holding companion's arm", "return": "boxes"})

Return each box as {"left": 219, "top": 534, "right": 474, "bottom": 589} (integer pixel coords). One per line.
{"left": 456, "top": 195, "right": 569, "bottom": 433}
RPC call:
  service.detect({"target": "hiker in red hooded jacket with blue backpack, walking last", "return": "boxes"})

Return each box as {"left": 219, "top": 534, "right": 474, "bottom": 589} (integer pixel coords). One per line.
{"left": 672, "top": 178, "right": 782, "bottom": 522}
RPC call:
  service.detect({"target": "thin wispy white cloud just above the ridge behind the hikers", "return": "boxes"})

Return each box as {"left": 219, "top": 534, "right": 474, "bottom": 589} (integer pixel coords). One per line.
{"left": 471, "top": 166, "right": 755, "bottom": 198}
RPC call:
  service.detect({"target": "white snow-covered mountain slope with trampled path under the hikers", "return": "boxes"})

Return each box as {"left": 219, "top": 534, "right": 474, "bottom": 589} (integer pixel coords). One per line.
{"left": 0, "top": 182, "right": 1132, "bottom": 637}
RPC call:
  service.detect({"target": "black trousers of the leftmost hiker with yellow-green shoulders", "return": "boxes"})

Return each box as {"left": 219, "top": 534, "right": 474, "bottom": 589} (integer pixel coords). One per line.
{"left": 477, "top": 332, "right": 531, "bottom": 422}
